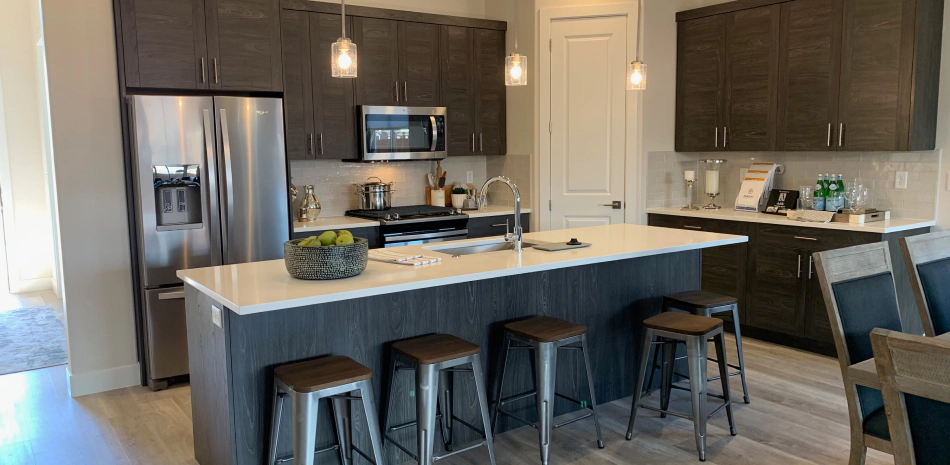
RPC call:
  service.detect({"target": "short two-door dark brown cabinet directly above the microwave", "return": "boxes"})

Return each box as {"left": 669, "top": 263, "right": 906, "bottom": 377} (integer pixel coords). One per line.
{"left": 354, "top": 18, "right": 441, "bottom": 106}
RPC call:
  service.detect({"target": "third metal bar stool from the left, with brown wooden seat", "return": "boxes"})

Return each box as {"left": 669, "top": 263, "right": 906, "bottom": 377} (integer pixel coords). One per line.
{"left": 492, "top": 316, "right": 604, "bottom": 465}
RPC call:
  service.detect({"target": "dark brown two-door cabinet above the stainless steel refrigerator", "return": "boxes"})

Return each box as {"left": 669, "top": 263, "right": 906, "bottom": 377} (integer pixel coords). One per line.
{"left": 119, "top": 0, "right": 283, "bottom": 92}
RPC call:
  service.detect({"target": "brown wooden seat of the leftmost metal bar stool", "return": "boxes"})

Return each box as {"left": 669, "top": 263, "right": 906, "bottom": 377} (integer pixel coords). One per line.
{"left": 274, "top": 355, "right": 373, "bottom": 393}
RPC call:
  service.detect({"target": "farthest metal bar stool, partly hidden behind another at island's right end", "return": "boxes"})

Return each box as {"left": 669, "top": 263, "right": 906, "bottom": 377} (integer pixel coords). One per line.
{"left": 646, "top": 291, "right": 750, "bottom": 404}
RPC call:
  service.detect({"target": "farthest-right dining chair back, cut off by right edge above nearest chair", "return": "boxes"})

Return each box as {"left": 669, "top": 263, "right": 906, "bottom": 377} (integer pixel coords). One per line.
{"left": 900, "top": 231, "right": 950, "bottom": 337}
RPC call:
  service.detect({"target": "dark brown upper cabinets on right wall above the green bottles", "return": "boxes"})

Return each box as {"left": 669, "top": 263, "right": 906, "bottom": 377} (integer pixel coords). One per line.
{"left": 677, "top": 0, "right": 944, "bottom": 151}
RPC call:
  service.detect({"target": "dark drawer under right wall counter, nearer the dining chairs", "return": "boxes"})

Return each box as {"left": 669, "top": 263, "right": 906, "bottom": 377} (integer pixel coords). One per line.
{"left": 756, "top": 225, "right": 882, "bottom": 252}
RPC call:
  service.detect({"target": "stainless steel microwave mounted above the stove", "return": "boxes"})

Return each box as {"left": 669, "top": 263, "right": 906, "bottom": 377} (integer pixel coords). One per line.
{"left": 359, "top": 105, "right": 447, "bottom": 161}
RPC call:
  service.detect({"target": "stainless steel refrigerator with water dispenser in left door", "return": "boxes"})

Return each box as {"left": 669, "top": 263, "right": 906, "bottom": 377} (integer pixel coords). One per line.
{"left": 129, "top": 95, "right": 290, "bottom": 389}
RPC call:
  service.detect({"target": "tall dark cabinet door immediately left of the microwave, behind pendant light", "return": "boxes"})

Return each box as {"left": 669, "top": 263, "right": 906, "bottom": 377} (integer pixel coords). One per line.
{"left": 310, "top": 13, "right": 363, "bottom": 160}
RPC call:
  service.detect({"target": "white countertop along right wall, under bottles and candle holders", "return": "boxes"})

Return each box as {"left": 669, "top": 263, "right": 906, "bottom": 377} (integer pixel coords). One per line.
{"left": 647, "top": 207, "right": 937, "bottom": 234}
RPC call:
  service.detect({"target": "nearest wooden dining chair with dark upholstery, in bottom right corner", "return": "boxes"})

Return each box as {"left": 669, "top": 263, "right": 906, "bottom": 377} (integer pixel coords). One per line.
{"left": 871, "top": 329, "right": 950, "bottom": 465}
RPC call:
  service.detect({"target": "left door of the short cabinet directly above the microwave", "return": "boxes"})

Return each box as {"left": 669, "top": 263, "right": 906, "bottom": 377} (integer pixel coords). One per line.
{"left": 356, "top": 17, "right": 402, "bottom": 105}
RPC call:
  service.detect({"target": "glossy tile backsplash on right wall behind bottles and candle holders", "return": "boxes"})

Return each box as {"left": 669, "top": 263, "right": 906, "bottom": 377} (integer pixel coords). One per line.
{"left": 647, "top": 151, "right": 940, "bottom": 219}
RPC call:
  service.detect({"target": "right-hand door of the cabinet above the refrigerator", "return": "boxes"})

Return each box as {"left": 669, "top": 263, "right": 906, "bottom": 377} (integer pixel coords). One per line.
{"left": 205, "top": 0, "right": 283, "bottom": 92}
